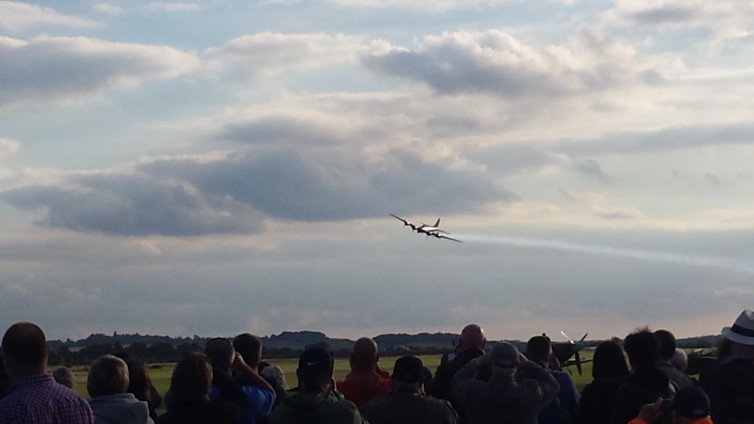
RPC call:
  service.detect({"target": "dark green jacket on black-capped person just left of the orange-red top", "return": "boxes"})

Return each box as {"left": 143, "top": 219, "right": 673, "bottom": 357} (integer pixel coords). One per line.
{"left": 269, "top": 392, "right": 368, "bottom": 424}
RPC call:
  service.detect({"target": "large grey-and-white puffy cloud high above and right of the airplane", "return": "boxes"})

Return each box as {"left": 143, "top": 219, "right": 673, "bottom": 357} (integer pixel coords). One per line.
{"left": 364, "top": 30, "right": 663, "bottom": 98}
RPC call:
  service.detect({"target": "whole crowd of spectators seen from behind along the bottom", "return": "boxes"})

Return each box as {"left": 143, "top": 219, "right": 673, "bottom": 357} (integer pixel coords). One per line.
{"left": 0, "top": 310, "right": 754, "bottom": 424}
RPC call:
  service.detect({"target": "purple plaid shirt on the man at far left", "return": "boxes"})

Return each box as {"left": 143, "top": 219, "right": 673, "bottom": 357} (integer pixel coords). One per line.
{"left": 0, "top": 374, "right": 94, "bottom": 424}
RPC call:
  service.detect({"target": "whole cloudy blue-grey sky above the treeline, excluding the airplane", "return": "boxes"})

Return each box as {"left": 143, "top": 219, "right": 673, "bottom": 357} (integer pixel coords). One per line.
{"left": 0, "top": 0, "right": 754, "bottom": 339}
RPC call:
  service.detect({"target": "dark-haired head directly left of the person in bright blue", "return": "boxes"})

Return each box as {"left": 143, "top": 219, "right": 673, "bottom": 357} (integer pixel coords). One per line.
{"left": 170, "top": 353, "right": 212, "bottom": 405}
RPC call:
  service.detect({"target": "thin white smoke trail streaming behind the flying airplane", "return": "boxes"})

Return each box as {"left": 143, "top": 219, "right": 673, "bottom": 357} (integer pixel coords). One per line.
{"left": 458, "top": 234, "right": 754, "bottom": 275}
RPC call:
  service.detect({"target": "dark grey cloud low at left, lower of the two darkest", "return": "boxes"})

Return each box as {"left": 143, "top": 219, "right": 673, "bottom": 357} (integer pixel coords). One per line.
{"left": 0, "top": 174, "right": 260, "bottom": 236}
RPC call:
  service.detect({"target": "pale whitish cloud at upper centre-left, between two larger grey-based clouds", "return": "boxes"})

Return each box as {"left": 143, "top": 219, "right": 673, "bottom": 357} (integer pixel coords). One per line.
{"left": 204, "top": 32, "right": 380, "bottom": 76}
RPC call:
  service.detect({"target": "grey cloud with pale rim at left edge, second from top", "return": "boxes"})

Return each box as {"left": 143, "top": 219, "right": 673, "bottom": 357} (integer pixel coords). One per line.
{"left": 0, "top": 37, "right": 199, "bottom": 105}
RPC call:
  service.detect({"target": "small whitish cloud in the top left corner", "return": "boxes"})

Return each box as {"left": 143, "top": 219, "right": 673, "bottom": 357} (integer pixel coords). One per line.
{"left": 0, "top": 1, "right": 97, "bottom": 32}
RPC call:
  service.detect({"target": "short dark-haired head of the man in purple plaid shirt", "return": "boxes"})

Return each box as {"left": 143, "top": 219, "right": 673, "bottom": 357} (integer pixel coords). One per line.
{"left": 2, "top": 322, "right": 48, "bottom": 378}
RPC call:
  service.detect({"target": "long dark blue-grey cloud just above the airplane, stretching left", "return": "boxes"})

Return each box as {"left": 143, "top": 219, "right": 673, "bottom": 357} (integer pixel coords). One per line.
{"left": 142, "top": 150, "right": 516, "bottom": 221}
